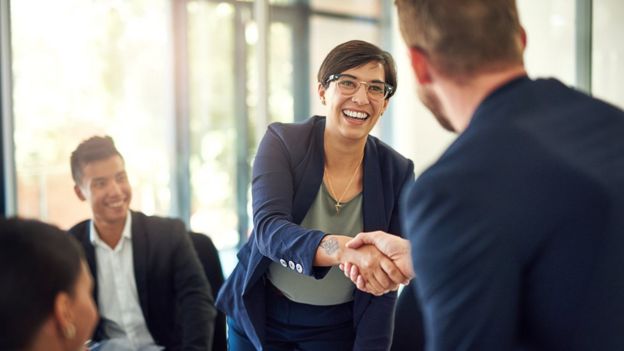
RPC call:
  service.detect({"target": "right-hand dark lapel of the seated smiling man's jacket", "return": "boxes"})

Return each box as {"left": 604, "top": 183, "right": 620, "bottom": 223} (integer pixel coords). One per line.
{"left": 130, "top": 211, "right": 149, "bottom": 320}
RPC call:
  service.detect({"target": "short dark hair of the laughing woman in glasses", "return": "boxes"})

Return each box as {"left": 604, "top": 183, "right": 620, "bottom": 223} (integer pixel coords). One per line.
{"left": 317, "top": 40, "right": 397, "bottom": 99}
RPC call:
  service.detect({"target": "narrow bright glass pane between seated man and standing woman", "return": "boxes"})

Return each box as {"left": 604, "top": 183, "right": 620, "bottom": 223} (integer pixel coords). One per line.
{"left": 187, "top": 1, "right": 239, "bottom": 249}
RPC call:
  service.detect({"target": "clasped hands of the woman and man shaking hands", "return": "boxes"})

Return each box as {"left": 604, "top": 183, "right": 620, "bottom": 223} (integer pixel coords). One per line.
{"left": 334, "top": 231, "right": 415, "bottom": 296}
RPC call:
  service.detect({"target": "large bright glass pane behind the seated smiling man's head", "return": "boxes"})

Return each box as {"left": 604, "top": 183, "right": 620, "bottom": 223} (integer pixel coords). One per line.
{"left": 11, "top": 0, "right": 172, "bottom": 228}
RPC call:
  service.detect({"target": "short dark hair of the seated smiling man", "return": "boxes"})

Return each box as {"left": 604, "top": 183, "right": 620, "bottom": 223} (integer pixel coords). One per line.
{"left": 70, "top": 135, "right": 123, "bottom": 184}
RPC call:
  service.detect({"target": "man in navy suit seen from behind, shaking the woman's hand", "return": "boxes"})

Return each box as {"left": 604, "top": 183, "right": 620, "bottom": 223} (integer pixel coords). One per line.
{"left": 346, "top": 0, "right": 624, "bottom": 351}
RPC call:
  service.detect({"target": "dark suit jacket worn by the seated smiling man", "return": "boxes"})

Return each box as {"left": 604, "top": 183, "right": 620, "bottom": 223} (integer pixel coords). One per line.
{"left": 69, "top": 211, "right": 216, "bottom": 350}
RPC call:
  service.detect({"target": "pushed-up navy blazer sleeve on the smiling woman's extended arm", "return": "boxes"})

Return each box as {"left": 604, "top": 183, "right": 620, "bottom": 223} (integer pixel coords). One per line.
{"left": 251, "top": 127, "right": 327, "bottom": 278}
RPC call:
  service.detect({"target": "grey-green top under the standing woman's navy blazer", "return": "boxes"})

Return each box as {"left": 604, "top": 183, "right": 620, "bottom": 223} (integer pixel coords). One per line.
{"left": 267, "top": 183, "right": 364, "bottom": 306}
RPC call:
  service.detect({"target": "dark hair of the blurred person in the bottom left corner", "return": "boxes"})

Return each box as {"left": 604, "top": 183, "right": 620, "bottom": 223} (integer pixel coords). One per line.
{"left": 0, "top": 218, "right": 84, "bottom": 350}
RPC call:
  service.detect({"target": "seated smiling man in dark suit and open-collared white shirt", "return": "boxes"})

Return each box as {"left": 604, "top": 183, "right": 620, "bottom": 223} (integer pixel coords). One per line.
{"left": 70, "top": 136, "right": 216, "bottom": 350}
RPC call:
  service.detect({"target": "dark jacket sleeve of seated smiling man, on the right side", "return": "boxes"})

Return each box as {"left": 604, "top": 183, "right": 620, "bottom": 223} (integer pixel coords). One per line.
{"left": 172, "top": 221, "right": 217, "bottom": 351}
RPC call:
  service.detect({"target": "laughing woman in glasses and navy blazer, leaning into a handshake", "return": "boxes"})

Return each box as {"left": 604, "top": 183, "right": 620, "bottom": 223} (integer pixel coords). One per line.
{"left": 217, "top": 41, "right": 414, "bottom": 351}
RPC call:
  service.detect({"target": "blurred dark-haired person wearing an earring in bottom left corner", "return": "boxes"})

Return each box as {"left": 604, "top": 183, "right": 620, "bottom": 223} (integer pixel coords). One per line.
{"left": 0, "top": 218, "right": 97, "bottom": 351}
